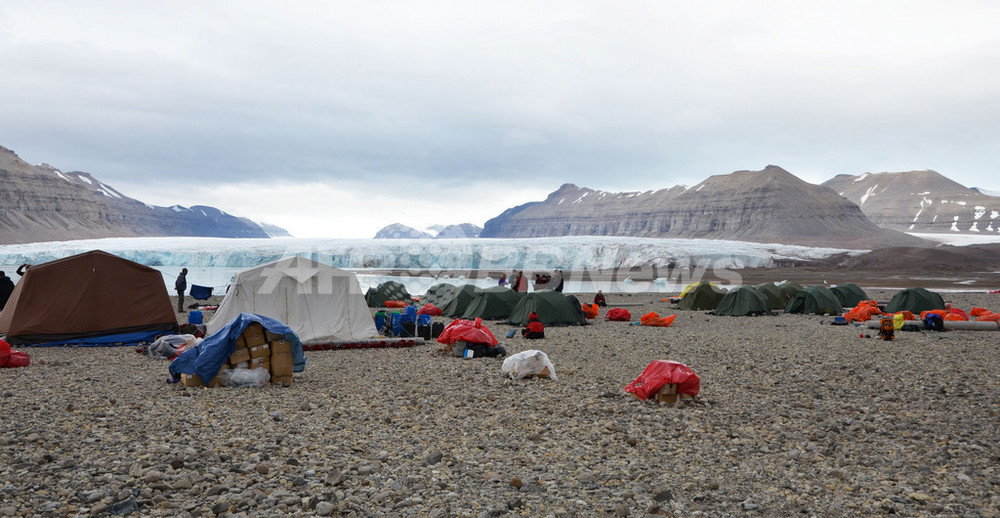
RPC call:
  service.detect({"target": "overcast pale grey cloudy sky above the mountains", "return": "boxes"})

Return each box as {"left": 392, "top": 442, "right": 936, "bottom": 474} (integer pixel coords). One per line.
{"left": 0, "top": 0, "right": 1000, "bottom": 237}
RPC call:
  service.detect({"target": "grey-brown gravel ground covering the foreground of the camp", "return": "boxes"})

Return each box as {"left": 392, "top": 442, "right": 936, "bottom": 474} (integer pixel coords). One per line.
{"left": 0, "top": 292, "right": 1000, "bottom": 517}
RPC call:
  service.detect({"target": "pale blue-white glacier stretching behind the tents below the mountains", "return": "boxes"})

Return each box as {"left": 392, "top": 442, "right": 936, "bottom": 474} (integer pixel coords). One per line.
{"left": 0, "top": 236, "right": 866, "bottom": 294}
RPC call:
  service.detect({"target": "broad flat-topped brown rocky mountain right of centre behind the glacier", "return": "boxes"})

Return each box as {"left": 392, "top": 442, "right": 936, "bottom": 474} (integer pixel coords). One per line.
{"left": 481, "top": 165, "right": 927, "bottom": 248}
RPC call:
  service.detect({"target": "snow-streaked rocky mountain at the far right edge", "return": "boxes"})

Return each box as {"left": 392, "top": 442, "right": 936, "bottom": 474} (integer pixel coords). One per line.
{"left": 823, "top": 171, "right": 1000, "bottom": 233}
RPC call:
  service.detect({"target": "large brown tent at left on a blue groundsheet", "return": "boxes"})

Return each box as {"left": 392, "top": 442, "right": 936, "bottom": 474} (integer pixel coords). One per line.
{"left": 0, "top": 250, "right": 177, "bottom": 343}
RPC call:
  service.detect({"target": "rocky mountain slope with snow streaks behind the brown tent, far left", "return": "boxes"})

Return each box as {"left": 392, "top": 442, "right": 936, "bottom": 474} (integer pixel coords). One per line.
{"left": 0, "top": 147, "right": 280, "bottom": 244}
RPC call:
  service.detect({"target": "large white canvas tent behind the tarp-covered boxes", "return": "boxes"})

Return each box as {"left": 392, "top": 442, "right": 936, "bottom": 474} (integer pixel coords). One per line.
{"left": 207, "top": 257, "right": 378, "bottom": 342}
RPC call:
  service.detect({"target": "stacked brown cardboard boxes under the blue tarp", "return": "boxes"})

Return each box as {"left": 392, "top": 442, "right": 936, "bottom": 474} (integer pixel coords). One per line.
{"left": 181, "top": 322, "right": 294, "bottom": 387}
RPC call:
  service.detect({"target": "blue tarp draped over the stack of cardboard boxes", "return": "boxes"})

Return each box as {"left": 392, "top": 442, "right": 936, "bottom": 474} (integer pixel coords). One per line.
{"left": 170, "top": 313, "right": 306, "bottom": 385}
